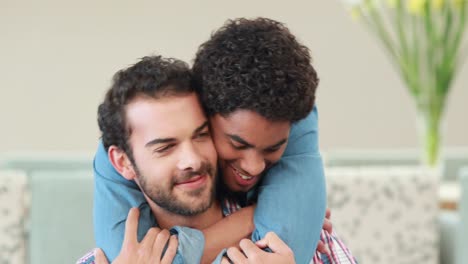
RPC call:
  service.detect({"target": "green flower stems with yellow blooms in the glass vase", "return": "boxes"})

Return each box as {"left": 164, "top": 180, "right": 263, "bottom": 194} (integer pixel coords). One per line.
{"left": 346, "top": 0, "right": 468, "bottom": 166}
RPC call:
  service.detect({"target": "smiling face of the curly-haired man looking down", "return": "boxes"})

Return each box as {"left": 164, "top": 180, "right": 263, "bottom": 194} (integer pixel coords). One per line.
{"left": 210, "top": 110, "right": 291, "bottom": 192}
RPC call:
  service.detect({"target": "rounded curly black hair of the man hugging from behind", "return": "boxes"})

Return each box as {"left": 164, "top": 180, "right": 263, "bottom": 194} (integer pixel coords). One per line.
{"left": 192, "top": 18, "right": 318, "bottom": 122}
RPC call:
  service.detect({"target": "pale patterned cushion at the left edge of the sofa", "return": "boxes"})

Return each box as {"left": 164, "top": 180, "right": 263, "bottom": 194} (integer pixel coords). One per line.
{"left": 0, "top": 171, "right": 28, "bottom": 264}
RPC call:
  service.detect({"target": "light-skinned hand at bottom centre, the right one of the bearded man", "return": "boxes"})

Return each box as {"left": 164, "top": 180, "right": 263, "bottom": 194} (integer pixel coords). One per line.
{"left": 221, "top": 232, "right": 296, "bottom": 264}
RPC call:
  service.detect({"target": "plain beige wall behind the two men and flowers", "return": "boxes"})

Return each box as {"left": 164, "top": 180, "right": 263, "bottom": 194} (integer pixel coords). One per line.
{"left": 0, "top": 0, "right": 468, "bottom": 153}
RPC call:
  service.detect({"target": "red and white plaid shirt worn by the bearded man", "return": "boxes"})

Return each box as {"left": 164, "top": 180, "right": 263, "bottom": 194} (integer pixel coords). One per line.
{"left": 76, "top": 199, "right": 357, "bottom": 264}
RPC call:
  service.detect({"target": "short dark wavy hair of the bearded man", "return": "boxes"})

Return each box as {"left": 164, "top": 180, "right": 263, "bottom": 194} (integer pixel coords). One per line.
{"left": 98, "top": 56, "right": 194, "bottom": 158}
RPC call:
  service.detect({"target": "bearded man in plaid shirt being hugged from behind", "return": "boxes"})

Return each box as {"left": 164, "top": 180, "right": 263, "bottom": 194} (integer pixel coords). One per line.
{"left": 78, "top": 56, "right": 294, "bottom": 263}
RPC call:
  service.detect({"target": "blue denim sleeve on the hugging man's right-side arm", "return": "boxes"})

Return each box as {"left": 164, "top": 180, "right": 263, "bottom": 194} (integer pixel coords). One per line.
{"left": 252, "top": 108, "right": 326, "bottom": 263}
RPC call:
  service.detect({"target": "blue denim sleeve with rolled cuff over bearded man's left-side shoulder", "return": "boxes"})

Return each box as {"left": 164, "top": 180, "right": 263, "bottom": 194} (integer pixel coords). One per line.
{"left": 93, "top": 142, "right": 205, "bottom": 264}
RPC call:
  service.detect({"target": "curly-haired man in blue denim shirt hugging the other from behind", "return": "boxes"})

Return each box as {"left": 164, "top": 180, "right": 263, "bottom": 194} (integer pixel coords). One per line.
{"left": 89, "top": 18, "right": 353, "bottom": 263}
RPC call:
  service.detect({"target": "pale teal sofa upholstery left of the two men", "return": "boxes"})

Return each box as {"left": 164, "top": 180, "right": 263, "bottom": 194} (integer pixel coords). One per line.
{"left": 0, "top": 153, "right": 94, "bottom": 264}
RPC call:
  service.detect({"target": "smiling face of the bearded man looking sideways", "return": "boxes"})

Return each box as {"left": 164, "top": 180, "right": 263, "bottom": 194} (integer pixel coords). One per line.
{"left": 126, "top": 93, "right": 216, "bottom": 216}
